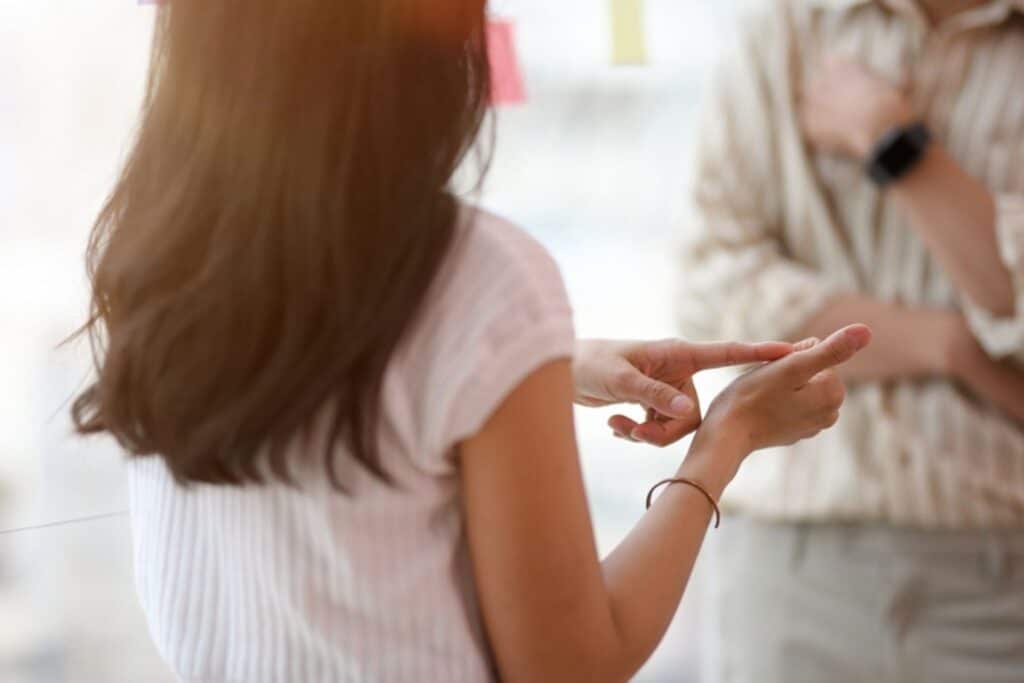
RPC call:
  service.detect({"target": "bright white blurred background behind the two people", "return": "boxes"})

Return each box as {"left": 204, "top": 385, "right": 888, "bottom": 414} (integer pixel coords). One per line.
{"left": 0, "top": 0, "right": 735, "bottom": 683}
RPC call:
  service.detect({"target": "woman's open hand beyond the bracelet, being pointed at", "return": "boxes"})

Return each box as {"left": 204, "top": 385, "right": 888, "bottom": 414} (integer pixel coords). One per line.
{"left": 698, "top": 325, "right": 871, "bottom": 457}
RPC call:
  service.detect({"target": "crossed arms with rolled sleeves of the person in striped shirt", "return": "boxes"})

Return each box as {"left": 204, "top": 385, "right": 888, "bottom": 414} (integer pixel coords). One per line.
{"left": 681, "top": 21, "right": 1024, "bottom": 421}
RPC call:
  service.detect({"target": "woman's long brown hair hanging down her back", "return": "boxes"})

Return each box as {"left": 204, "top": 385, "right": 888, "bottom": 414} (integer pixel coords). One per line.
{"left": 73, "top": 0, "right": 489, "bottom": 487}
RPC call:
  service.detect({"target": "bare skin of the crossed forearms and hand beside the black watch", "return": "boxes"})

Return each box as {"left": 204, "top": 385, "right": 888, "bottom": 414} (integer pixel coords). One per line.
{"left": 801, "top": 61, "right": 1024, "bottom": 422}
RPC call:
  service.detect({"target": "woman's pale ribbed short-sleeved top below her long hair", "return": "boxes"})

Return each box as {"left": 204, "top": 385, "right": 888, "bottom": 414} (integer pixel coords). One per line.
{"left": 129, "top": 213, "right": 573, "bottom": 683}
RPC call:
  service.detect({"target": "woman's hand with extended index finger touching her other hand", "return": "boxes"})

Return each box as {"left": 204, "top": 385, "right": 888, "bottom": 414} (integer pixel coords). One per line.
{"left": 572, "top": 339, "right": 793, "bottom": 445}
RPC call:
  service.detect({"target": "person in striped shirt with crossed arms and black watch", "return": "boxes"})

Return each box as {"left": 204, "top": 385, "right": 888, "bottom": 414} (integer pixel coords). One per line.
{"left": 679, "top": 0, "right": 1024, "bottom": 683}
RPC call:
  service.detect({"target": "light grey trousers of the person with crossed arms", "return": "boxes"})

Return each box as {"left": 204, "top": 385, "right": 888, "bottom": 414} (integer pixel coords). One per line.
{"left": 700, "top": 517, "right": 1024, "bottom": 683}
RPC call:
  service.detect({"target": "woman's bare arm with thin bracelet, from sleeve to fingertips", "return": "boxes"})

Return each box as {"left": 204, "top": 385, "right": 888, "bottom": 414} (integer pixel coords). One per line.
{"left": 460, "top": 328, "right": 867, "bottom": 682}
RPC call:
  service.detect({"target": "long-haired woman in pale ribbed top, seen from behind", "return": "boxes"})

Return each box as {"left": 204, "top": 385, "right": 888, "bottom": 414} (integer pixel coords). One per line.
{"left": 75, "top": 0, "right": 867, "bottom": 682}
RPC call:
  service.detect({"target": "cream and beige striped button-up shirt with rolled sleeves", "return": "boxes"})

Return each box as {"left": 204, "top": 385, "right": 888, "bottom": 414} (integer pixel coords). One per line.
{"left": 680, "top": 0, "right": 1024, "bottom": 528}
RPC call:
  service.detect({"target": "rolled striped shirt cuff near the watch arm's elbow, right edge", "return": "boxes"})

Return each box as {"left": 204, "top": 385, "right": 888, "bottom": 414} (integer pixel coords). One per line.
{"left": 963, "top": 195, "right": 1024, "bottom": 362}
